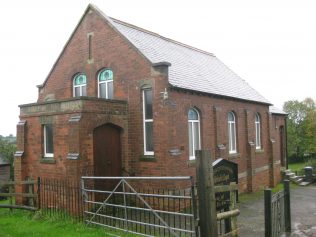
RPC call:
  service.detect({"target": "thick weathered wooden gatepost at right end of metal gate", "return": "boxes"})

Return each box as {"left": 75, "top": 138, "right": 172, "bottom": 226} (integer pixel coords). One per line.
{"left": 195, "top": 150, "right": 218, "bottom": 237}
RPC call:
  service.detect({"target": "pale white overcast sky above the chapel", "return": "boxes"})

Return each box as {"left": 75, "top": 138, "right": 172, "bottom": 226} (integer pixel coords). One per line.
{"left": 0, "top": 0, "right": 316, "bottom": 135}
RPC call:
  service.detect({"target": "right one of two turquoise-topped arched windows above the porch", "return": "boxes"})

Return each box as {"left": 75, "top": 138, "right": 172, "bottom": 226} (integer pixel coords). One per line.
{"left": 98, "top": 68, "right": 113, "bottom": 99}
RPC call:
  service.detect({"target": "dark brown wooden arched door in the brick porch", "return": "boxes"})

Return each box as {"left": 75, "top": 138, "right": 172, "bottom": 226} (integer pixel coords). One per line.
{"left": 93, "top": 124, "right": 122, "bottom": 176}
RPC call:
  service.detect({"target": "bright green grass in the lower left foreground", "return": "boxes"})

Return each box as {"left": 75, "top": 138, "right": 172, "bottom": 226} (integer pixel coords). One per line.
{"left": 0, "top": 201, "right": 134, "bottom": 237}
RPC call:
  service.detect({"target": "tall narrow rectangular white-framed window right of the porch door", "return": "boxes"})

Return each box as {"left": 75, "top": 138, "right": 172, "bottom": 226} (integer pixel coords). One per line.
{"left": 143, "top": 89, "right": 154, "bottom": 155}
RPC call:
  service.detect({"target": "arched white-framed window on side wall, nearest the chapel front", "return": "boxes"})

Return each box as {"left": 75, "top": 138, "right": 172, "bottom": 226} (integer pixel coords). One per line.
{"left": 188, "top": 109, "right": 201, "bottom": 160}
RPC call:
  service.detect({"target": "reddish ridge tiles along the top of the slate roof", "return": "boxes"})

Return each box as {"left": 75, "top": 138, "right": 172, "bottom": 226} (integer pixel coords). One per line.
{"left": 109, "top": 17, "right": 216, "bottom": 57}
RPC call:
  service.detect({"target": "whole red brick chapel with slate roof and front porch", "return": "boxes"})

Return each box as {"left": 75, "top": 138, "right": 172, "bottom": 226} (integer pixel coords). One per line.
{"left": 14, "top": 5, "right": 286, "bottom": 192}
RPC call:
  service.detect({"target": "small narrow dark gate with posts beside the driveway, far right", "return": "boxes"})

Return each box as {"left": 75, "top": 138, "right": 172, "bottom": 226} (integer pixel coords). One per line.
{"left": 264, "top": 180, "right": 291, "bottom": 237}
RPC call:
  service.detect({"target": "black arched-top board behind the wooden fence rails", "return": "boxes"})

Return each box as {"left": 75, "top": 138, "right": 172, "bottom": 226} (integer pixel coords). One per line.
{"left": 213, "top": 158, "right": 238, "bottom": 211}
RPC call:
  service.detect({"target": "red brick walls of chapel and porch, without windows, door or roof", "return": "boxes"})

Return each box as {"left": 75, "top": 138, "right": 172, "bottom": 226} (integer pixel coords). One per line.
{"left": 15, "top": 7, "right": 285, "bottom": 192}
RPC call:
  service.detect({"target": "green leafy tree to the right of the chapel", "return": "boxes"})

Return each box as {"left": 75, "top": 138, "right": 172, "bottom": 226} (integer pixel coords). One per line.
{"left": 283, "top": 98, "right": 316, "bottom": 158}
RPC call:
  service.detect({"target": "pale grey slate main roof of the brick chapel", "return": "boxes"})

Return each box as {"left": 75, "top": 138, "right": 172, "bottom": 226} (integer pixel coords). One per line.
{"left": 39, "top": 4, "right": 270, "bottom": 104}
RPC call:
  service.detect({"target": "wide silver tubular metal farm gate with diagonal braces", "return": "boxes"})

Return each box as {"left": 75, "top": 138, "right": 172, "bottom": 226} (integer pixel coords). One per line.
{"left": 81, "top": 176, "right": 198, "bottom": 236}
